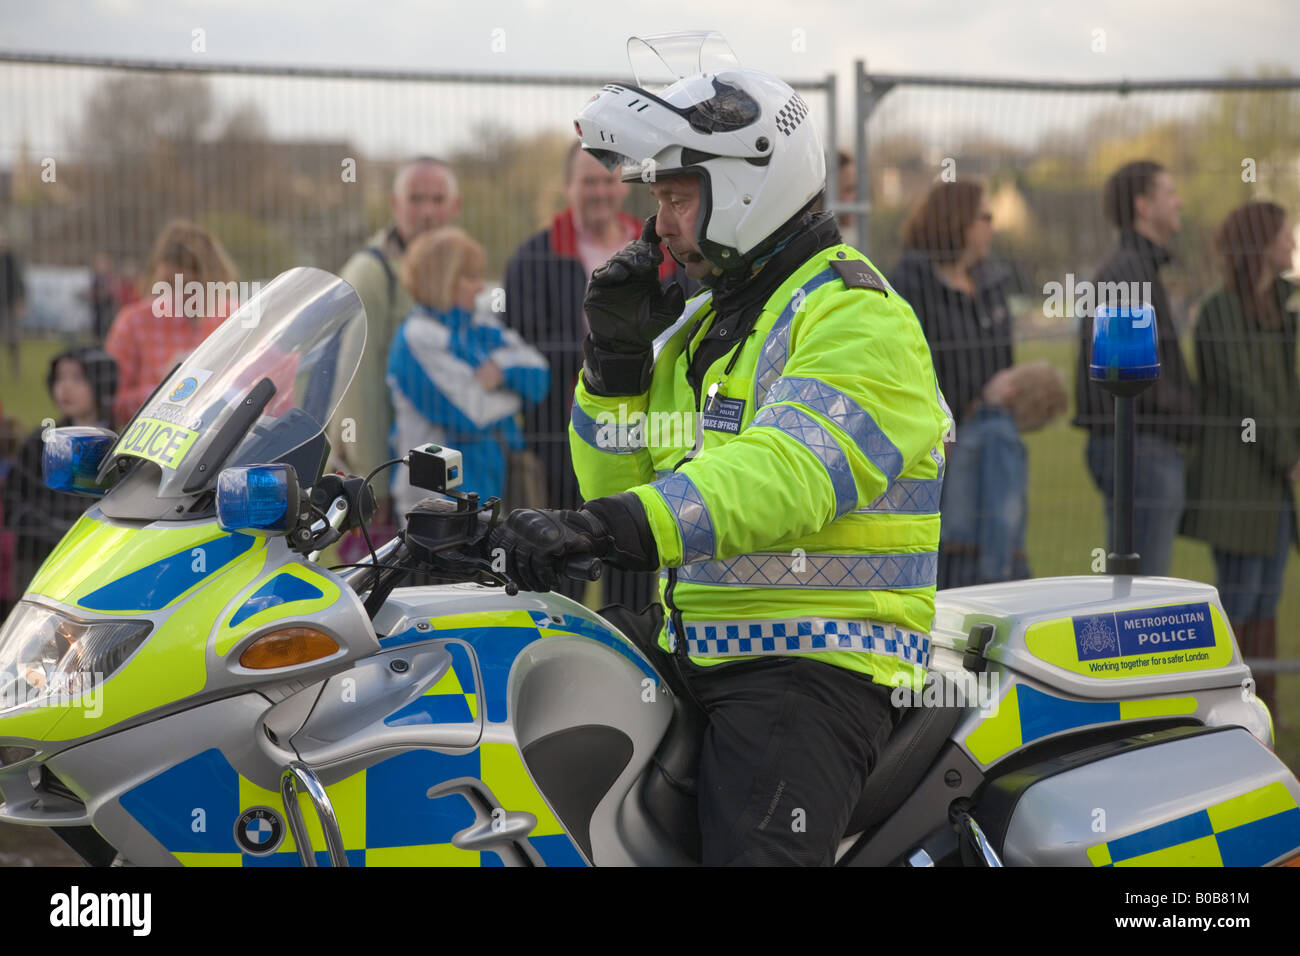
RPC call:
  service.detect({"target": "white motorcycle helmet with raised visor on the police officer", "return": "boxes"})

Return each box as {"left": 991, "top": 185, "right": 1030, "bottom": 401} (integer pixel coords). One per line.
{"left": 573, "top": 35, "right": 826, "bottom": 272}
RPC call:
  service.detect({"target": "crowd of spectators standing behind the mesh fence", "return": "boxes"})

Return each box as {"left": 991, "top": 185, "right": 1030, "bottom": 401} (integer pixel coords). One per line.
{"left": 0, "top": 151, "right": 1300, "bottom": 717}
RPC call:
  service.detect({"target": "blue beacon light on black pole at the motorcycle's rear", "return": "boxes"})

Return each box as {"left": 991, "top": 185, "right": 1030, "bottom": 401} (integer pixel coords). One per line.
{"left": 1088, "top": 304, "right": 1160, "bottom": 575}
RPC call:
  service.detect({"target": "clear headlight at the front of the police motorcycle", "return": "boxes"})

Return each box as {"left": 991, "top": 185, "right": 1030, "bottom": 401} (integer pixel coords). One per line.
{"left": 0, "top": 601, "right": 153, "bottom": 713}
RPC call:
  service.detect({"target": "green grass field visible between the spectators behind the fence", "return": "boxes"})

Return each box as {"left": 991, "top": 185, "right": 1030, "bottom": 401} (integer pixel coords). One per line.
{"left": 0, "top": 339, "right": 1300, "bottom": 769}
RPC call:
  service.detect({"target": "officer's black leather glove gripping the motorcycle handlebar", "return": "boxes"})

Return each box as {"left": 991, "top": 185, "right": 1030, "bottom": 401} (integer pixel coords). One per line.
{"left": 488, "top": 493, "right": 659, "bottom": 591}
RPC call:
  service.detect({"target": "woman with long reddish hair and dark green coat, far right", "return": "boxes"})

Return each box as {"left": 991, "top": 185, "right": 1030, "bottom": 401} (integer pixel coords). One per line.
{"left": 1182, "top": 202, "right": 1300, "bottom": 717}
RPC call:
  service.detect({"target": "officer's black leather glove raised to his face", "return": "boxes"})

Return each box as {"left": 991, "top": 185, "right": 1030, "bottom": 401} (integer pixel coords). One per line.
{"left": 582, "top": 216, "right": 685, "bottom": 395}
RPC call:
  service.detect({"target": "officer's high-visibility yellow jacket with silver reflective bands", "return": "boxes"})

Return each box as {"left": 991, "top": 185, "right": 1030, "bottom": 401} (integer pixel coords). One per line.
{"left": 569, "top": 238, "right": 950, "bottom": 691}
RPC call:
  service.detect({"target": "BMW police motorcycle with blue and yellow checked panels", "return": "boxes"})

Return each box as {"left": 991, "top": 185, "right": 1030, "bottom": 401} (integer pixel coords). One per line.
{"left": 0, "top": 268, "right": 1300, "bottom": 866}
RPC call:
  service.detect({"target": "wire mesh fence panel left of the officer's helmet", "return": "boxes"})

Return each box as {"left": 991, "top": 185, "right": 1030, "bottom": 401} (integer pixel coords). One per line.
{"left": 0, "top": 55, "right": 835, "bottom": 606}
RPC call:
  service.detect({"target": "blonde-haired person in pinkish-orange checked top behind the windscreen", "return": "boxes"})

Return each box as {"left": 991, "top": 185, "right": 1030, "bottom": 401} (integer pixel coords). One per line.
{"left": 104, "top": 220, "right": 239, "bottom": 428}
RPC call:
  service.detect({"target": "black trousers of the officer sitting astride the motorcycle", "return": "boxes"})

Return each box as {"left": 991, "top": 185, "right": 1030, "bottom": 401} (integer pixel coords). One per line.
{"left": 688, "top": 657, "right": 893, "bottom": 866}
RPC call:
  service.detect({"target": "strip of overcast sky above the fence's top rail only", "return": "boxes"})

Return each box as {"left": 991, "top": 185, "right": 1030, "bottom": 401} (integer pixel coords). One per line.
{"left": 0, "top": 0, "right": 1300, "bottom": 82}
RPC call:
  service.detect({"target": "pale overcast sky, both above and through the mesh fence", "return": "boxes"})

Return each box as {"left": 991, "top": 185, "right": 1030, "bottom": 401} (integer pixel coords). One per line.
{"left": 0, "top": 0, "right": 1300, "bottom": 165}
